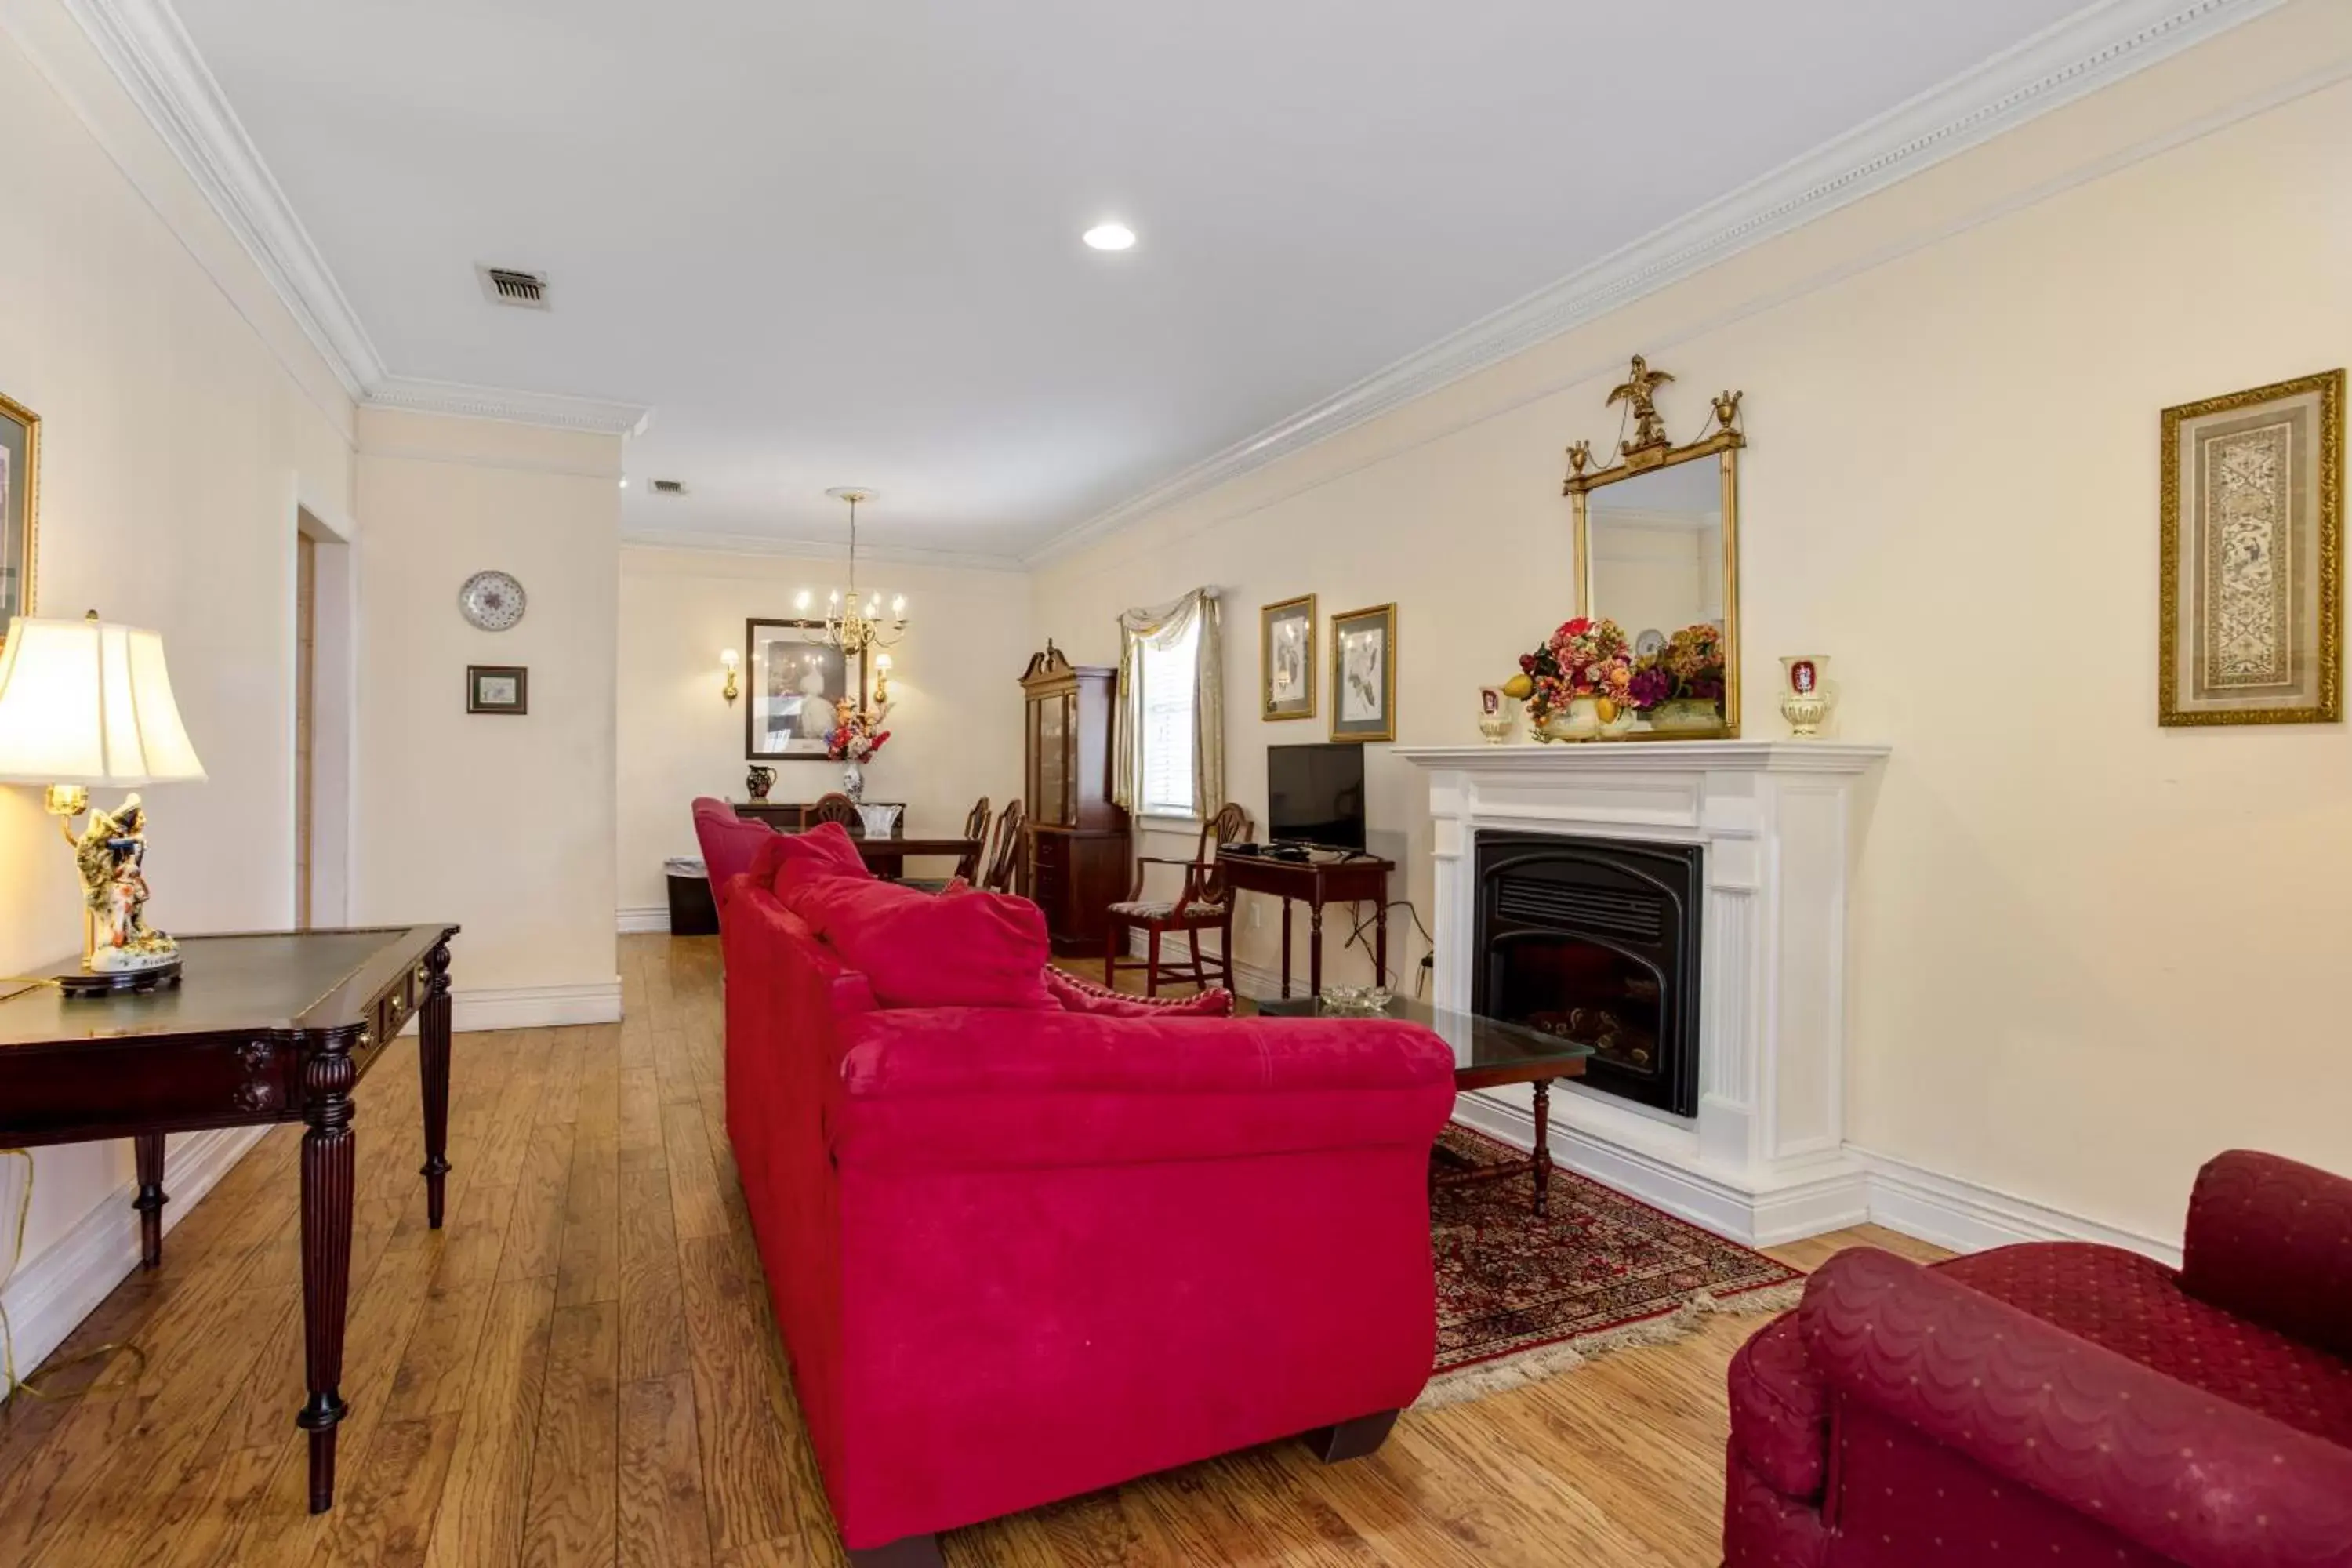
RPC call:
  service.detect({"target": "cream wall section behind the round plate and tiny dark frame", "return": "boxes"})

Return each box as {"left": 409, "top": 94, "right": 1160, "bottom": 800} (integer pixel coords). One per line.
{"left": 353, "top": 409, "right": 621, "bottom": 1029}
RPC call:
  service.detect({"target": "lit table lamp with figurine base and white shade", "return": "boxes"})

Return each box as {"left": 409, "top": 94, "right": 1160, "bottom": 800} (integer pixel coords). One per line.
{"left": 0, "top": 612, "right": 205, "bottom": 994}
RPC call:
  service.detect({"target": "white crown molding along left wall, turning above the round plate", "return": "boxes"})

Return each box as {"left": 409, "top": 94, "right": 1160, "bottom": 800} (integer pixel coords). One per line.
{"left": 61, "top": 0, "right": 652, "bottom": 435}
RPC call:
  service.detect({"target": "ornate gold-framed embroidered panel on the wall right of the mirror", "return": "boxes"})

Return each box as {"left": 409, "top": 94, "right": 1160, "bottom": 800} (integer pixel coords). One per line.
{"left": 2157, "top": 369, "right": 2345, "bottom": 724}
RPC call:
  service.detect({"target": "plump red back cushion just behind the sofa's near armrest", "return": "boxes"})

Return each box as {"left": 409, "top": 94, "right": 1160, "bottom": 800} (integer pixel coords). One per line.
{"left": 779, "top": 879, "right": 1058, "bottom": 1011}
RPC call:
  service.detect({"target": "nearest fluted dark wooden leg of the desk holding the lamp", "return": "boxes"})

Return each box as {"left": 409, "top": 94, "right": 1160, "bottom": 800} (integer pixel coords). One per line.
{"left": 294, "top": 1044, "right": 358, "bottom": 1514}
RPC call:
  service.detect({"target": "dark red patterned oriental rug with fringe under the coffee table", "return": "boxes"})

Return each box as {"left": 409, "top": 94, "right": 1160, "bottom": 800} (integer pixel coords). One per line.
{"left": 1418, "top": 1123, "right": 1804, "bottom": 1408}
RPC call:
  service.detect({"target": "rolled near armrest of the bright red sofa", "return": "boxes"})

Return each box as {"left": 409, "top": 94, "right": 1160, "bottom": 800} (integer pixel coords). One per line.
{"left": 833, "top": 1008, "right": 1454, "bottom": 1168}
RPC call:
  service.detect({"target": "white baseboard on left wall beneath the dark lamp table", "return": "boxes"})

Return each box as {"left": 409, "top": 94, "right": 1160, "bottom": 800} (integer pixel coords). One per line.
{"left": 0, "top": 1126, "right": 270, "bottom": 1399}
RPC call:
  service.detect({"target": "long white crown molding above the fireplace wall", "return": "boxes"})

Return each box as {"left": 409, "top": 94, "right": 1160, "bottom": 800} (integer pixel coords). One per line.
{"left": 1023, "top": 0, "right": 2286, "bottom": 567}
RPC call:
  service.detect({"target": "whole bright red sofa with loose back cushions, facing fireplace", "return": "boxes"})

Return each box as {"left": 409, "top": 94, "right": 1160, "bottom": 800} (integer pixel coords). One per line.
{"left": 722, "top": 827, "right": 1454, "bottom": 1563}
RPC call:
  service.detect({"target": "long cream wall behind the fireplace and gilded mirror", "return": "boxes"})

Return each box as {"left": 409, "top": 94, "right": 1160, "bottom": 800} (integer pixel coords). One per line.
{"left": 1035, "top": 0, "right": 2352, "bottom": 1236}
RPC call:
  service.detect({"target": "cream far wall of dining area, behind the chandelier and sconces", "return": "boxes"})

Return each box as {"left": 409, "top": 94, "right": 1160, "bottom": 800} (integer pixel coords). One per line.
{"left": 607, "top": 546, "right": 1033, "bottom": 914}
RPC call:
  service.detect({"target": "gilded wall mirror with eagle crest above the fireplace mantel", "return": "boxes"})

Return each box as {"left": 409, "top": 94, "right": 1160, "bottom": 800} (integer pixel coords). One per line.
{"left": 1562, "top": 355, "right": 1748, "bottom": 741}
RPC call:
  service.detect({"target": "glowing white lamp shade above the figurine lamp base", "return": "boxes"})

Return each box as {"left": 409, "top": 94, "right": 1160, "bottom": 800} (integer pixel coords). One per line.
{"left": 0, "top": 616, "right": 205, "bottom": 787}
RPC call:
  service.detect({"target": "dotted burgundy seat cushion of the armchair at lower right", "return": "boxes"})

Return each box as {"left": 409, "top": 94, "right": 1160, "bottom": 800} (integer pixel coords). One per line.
{"left": 1936, "top": 1241, "right": 2352, "bottom": 1448}
